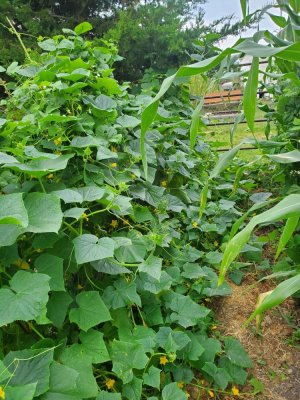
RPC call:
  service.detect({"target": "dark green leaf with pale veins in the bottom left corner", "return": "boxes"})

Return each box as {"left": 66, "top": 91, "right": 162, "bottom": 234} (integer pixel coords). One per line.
{"left": 4, "top": 349, "right": 53, "bottom": 397}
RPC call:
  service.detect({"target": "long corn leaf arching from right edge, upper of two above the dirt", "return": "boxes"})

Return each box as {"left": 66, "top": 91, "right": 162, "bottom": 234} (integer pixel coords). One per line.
{"left": 219, "top": 194, "right": 300, "bottom": 284}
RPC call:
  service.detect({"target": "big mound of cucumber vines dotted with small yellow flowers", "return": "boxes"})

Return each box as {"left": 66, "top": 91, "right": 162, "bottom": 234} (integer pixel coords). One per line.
{"left": 0, "top": 23, "right": 251, "bottom": 400}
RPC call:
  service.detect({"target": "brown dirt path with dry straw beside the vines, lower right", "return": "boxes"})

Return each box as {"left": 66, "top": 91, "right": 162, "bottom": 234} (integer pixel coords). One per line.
{"left": 214, "top": 274, "right": 300, "bottom": 400}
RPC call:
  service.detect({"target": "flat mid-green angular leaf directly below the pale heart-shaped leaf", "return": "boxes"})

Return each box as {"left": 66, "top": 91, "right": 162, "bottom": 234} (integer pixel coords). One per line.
{"left": 69, "top": 291, "right": 111, "bottom": 332}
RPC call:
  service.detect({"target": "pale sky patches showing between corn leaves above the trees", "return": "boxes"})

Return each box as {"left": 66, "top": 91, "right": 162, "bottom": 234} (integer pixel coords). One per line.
{"left": 202, "top": 0, "right": 278, "bottom": 48}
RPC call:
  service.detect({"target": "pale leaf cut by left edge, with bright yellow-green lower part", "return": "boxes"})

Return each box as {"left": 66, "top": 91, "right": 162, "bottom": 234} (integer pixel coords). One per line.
{"left": 0, "top": 193, "right": 28, "bottom": 228}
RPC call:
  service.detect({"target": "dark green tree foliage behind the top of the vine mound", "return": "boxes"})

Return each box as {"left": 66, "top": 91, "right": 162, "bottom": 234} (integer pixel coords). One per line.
{"left": 0, "top": 0, "right": 251, "bottom": 80}
